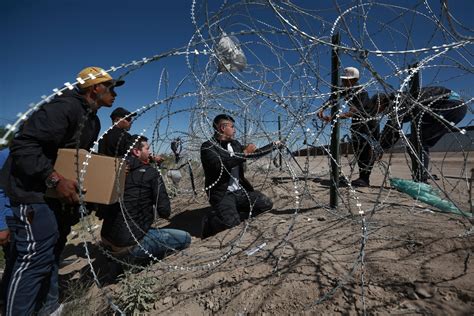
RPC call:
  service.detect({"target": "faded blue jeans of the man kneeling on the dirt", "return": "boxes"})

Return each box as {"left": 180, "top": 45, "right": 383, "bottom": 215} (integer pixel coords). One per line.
{"left": 129, "top": 228, "right": 191, "bottom": 262}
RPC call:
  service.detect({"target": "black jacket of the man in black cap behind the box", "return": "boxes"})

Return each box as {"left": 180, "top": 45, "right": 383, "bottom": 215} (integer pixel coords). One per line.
{"left": 99, "top": 126, "right": 134, "bottom": 157}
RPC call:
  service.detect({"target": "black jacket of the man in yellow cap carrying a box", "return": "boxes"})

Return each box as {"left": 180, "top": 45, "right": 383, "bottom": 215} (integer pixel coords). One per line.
{"left": 0, "top": 90, "right": 100, "bottom": 204}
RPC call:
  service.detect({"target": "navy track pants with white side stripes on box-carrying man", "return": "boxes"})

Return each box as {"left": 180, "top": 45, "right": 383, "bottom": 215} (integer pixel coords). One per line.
{"left": 6, "top": 204, "right": 59, "bottom": 315}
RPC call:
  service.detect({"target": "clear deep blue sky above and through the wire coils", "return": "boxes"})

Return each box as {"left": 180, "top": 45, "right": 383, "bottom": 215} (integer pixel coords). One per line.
{"left": 0, "top": 0, "right": 474, "bottom": 152}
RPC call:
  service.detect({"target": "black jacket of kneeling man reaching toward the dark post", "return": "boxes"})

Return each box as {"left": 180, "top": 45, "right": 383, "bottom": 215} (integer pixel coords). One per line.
{"left": 201, "top": 138, "right": 273, "bottom": 205}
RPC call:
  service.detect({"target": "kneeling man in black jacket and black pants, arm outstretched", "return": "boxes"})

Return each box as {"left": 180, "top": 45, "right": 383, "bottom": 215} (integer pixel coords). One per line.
{"left": 201, "top": 114, "right": 282, "bottom": 238}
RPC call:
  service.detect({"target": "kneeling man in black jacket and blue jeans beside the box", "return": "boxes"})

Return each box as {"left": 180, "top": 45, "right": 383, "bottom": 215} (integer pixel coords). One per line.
{"left": 101, "top": 136, "right": 191, "bottom": 264}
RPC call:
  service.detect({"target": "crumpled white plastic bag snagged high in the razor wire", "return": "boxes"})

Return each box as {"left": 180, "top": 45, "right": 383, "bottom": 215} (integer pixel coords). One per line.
{"left": 216, "top": 32, "right": 247, "bottom": 72}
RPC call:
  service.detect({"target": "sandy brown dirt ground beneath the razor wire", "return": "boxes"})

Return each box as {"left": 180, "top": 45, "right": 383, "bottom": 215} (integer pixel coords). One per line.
{"left": 60, "top": 153, "right": 474, "bottom": 315}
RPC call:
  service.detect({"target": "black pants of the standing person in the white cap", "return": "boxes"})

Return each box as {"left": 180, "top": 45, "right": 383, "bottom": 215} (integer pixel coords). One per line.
{"left": 351, "top": 122, "right": 379, "bottom": 182}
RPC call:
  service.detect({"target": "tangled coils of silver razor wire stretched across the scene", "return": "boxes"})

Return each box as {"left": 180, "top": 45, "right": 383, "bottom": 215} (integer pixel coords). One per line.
{"left": 0, "top": 0, "right": 474, "bottom": 314}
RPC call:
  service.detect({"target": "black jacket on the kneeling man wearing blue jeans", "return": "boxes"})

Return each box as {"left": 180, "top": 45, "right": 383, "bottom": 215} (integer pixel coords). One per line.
{"left": 101, "top": 157, "right": 171, "bottom": 247}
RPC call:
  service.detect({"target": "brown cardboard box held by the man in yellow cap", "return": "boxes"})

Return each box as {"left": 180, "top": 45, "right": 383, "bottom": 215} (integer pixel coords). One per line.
{"left": 46, "top": 149, "right": 125, "bottom": 204}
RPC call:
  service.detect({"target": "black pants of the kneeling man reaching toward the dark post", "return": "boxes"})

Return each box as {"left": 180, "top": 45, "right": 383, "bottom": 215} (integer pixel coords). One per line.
{"left": 202, "top": 190, "right": 273, "bottom": 238}
